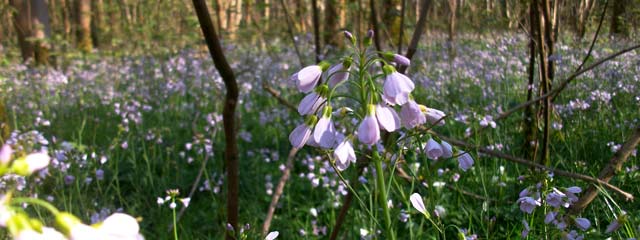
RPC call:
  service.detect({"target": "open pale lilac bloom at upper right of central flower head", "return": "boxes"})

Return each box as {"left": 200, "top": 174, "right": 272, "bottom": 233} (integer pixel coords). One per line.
{"left": 382, "top": 65, "right": 415, "bottom": 105}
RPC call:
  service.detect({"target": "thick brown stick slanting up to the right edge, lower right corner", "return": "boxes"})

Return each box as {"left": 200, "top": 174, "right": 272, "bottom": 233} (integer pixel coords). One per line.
{"left": 569, "top": 127, "right": 640, "bottom": 215}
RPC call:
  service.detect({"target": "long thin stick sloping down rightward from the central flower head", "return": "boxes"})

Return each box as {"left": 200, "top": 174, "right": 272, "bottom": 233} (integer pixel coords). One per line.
{"left": 430, "top": 131, "right": 633, "bottom": 201}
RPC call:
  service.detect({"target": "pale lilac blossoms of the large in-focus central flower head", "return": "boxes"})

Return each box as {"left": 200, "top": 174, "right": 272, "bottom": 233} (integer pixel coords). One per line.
{"left": 289, "top": 42, "right": 452, "bottom": 170}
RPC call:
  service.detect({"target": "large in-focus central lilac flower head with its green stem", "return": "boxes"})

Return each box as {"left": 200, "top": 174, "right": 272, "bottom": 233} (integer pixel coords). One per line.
{"left": 289, "top": 31, "right": 473, "bottom": 239}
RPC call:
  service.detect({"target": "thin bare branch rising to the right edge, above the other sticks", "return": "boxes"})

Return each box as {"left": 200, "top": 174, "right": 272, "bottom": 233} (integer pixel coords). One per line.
{"left": 466, "top": 44, "right": 640, "bottom": 139}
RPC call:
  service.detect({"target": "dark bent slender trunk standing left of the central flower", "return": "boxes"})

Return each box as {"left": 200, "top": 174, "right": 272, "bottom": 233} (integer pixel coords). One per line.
{"left": 193, "top": 0, "right": 240, "bottom": 240}
